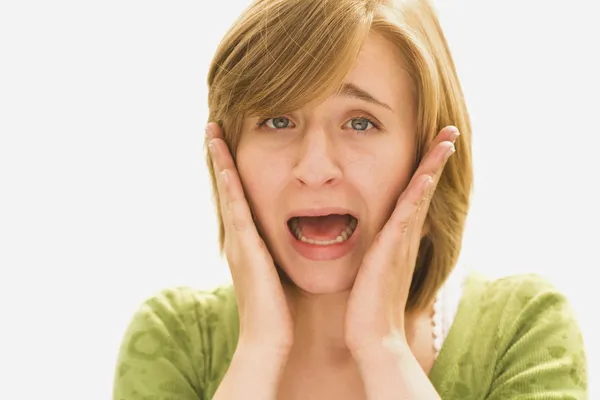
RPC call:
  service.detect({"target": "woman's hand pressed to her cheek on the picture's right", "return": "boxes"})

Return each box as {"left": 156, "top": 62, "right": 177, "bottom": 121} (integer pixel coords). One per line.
{"left": 345, "top": 127, "right": 458, "bottom": 355}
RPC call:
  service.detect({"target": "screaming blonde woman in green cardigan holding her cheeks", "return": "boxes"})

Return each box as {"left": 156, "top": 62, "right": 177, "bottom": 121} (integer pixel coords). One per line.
{"left": 114, "top": 0, "right": 587, "bottom": 400}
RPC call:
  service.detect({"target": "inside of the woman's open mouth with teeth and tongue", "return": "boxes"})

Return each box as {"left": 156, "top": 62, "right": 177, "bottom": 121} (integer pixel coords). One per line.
{"left": 287, "top": 214, "right": 358, "bottom": 246}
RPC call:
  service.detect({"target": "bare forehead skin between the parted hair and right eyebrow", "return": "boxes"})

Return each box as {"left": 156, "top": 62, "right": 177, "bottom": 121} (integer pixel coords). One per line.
{"left": 345, "top": 33, "right": 413, "bottom": 113}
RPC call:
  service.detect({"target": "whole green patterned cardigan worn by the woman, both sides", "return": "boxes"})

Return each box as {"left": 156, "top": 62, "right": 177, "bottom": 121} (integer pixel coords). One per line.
{"left": 113, "top": 272, "right": 587, "bottom": 400}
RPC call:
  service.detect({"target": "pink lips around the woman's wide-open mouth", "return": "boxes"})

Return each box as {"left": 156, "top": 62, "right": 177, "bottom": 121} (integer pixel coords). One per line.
{"left": 284, "top": 207, "right": 360, "bottom": 261}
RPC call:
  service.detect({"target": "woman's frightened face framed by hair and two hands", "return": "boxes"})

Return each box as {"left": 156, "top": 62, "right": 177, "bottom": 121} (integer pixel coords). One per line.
{"left": 236, "top": 34, "right": 416, "bottom": 293}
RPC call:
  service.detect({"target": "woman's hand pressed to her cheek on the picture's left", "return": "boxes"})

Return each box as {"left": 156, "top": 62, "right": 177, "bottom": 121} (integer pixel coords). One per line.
{"left": 206, "top": 123, "right": 293, "bottom": 354}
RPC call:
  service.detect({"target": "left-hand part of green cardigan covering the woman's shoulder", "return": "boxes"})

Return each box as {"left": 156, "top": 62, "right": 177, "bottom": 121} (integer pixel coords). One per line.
{"left": 114, "top": 286, "right": 238, "bottom": 399}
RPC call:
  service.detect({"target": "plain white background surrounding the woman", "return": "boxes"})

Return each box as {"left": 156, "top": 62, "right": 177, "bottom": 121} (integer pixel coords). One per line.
{"left": 0, "top": 0, "right": 600, "bottom": 399}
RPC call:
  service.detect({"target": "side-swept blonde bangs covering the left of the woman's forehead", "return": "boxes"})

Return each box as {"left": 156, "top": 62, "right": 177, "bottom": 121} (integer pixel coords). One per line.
{"left": 209, "top": 0, "right": 375, "bottom": 117}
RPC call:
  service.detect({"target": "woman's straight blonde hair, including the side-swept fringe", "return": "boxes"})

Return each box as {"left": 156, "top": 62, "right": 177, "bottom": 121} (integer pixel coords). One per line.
{"left": 206, "top": 0, "right": 473, "bottom": 310}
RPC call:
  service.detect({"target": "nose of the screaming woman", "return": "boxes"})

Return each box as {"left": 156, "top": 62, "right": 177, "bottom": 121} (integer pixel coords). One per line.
{"left": 293, "top": 129, "right": 342, "bottom": 189}
